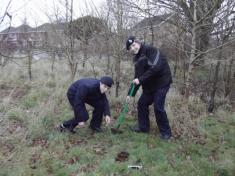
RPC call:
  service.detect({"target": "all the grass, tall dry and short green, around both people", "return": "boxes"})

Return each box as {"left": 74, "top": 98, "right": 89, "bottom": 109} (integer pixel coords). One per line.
{"left": 0, "top": 59, "right": 235, "bottom": 176}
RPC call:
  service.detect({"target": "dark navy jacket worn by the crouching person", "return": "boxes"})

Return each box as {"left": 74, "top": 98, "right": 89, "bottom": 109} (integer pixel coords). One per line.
{"left": 68, "top": 78, "right": 110, "bottom": 116}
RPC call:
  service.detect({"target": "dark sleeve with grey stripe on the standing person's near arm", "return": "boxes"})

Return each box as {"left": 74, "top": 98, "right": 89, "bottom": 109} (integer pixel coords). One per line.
{"left": 139, "top": 52, "right": 164, "bottom": 84}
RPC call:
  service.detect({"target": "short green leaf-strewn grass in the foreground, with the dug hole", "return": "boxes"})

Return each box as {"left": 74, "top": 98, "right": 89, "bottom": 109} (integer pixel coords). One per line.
{"left": 0, "top": 117, "right": 235, "bottom": 176}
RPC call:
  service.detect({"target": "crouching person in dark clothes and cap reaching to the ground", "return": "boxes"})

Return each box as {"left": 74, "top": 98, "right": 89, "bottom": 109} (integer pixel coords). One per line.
{"left": 59, "top": 76, "right": 113, "bottom": 133}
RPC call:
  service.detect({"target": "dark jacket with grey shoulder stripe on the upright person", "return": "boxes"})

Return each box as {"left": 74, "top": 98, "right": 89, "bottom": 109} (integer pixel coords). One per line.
{"left": 128, "top": 44, "right": 172, "bottom": 96}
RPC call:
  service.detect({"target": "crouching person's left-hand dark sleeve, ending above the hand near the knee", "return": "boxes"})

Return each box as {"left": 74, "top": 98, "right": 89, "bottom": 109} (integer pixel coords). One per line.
{"left": 74, "top": 87, "right": 89, "bottom": 122}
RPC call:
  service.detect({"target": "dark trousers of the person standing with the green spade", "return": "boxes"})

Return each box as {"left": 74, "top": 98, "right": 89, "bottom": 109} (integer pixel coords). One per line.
{"left": 138, "top": 86, "right": 171, "bottom": 135}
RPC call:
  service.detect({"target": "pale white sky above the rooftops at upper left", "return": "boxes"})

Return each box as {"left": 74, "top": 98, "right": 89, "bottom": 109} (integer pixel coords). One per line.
{"left": 0, "top": 0, "right": 105, "bottom": 31}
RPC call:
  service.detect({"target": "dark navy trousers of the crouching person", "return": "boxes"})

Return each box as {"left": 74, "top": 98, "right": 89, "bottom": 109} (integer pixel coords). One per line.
{"left": 63, "top": 92, "right": 104, "bottom": 129}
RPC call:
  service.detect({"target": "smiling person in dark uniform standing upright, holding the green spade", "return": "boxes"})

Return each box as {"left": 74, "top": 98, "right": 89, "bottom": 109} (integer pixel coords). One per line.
{"left": 126, "top": 36, "right": 172, "bottom": 139}
